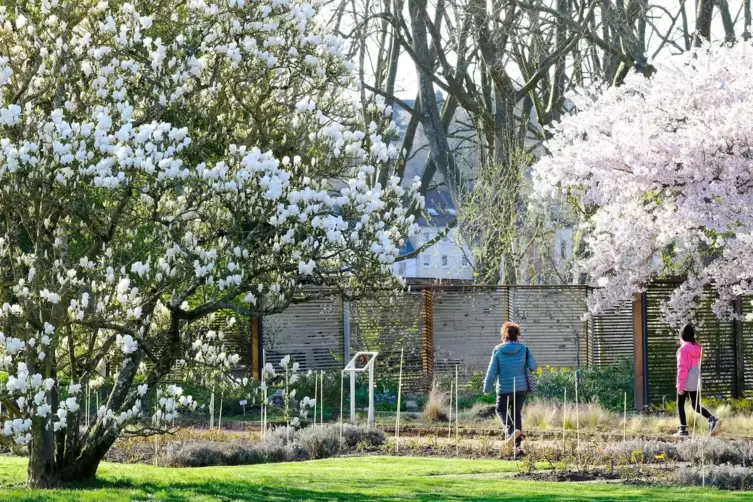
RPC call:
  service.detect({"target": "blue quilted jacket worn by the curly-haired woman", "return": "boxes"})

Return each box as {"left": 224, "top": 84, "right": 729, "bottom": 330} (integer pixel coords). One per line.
{"left": 484, "top": 342, "right": 538, "bottom": 394}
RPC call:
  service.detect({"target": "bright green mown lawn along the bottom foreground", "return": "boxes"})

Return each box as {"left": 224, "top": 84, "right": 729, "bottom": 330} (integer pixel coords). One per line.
{"left": 0, "top": 457, "right": 751, "bottom": 502}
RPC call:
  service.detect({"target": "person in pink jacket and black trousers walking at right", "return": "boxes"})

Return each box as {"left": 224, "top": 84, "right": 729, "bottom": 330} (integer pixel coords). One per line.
{"left": 675, "top": 324, "right": 721, "bottom": 436}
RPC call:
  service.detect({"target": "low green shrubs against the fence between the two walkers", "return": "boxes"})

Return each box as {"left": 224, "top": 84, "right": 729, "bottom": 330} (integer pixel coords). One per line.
{"left": 537, "top": 360, "right": 633, "bottom": 411}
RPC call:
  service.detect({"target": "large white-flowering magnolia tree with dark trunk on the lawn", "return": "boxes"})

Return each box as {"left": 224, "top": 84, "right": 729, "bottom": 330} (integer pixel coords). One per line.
{"left": 0, "top": 0, "right": 422, "bottom": 487}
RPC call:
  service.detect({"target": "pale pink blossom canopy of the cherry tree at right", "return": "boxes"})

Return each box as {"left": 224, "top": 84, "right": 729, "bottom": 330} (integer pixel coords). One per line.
{"left": 533, "top": 44, "right": 753, "bottom": 326}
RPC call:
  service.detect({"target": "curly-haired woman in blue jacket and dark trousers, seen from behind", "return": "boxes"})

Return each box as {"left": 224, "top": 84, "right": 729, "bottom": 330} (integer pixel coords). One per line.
{"left": 484, "top": 322, "right": 538, "bottom": 448}
